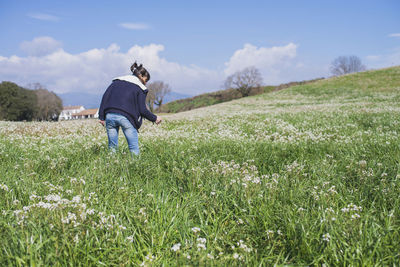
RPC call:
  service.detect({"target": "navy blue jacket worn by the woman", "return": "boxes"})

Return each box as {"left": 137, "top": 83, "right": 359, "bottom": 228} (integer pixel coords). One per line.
{"left": 99, "top": 79, "right": 157, "bottom": 130}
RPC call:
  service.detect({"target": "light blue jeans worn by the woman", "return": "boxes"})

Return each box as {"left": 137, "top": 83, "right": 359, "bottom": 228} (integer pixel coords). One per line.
{"left": 106, "top": 113, "right": 139, "bottom": 155}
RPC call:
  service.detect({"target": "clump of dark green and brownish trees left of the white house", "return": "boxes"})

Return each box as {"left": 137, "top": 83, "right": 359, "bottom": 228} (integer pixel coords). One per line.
{"left": 0, "top": 81, "right": 63, "bottom": 121}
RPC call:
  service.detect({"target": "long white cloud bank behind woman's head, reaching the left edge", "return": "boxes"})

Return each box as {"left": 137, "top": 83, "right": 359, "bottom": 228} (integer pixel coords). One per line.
{"left": 0, "top": 39, "right": 219, "bottom": 94}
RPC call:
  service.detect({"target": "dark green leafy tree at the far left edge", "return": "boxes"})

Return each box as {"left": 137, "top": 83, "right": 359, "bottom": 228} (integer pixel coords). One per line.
{"left": 0, "top": 82, "right": 37, "bottom": 121}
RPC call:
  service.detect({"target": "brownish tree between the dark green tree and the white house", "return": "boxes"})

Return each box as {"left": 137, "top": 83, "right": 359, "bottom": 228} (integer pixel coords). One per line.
{"left": 28, "top": 83, "right": 63, "bottom": 121}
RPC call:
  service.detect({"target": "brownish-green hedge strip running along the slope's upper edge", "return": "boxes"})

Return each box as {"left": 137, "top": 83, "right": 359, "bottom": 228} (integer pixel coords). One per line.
{"left": 158, "top": 79, "right": 320, "bottom": 113}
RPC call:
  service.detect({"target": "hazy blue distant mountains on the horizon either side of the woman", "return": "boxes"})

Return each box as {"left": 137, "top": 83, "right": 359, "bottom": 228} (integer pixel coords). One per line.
{"left": 57, "top": 92, "right": 191, "bottom": 109}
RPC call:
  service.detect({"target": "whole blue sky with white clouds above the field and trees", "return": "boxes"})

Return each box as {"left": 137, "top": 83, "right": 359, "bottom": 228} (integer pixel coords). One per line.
{"left": 0, "top": 0, "right": 400, "bottom": 95}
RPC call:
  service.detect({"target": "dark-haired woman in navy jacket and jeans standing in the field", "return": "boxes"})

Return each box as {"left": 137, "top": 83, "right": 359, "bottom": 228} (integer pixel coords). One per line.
{"left": 99, "top": 62, "right": 162, "bottom": 155}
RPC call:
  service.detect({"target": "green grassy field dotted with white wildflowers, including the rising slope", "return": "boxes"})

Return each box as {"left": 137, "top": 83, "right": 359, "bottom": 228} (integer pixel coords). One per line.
{"left": 0, "top": 67, "right": 400, "bottom": 266}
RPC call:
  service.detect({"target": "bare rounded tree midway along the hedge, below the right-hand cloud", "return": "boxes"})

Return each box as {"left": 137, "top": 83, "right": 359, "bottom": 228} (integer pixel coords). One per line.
{"left": 224, "top": 67, "right": 262, "bottom": 97}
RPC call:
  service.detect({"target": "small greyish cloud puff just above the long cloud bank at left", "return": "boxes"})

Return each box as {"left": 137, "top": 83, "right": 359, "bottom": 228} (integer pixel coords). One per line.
{"left": 20, "top": 36, "right": 62, "bottom": 56}
